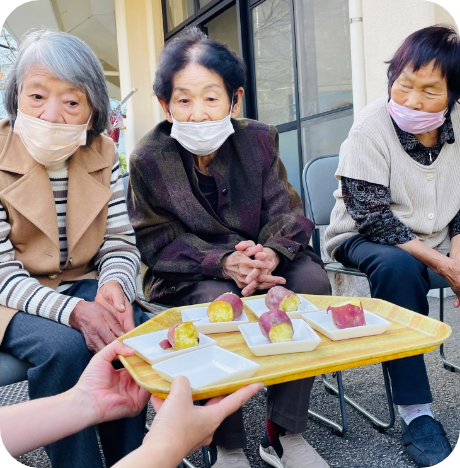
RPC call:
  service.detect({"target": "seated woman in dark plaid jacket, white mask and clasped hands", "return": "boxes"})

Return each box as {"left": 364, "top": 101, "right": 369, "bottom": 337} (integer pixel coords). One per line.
{"left": 128, "top": 28, "right": 330, "bottom": 468}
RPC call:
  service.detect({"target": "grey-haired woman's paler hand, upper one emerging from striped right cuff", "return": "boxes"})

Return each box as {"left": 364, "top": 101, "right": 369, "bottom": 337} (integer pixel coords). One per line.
{"left": 94, "top": 281, "right": 134, "bottom": 333}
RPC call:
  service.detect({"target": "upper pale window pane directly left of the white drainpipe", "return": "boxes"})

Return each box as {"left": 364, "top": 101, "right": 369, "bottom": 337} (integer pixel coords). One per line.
{"left": 294, "top": 0, "right": 353, "bottom": 117}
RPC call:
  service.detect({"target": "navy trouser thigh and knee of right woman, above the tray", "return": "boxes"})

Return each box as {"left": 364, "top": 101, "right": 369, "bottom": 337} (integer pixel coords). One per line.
{"left": 335, "top": 234, "right": 430, "bottom": 315}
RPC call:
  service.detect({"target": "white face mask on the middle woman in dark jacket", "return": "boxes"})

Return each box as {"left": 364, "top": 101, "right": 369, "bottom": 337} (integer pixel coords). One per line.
{"left": 169, "top": 104, "right": 235, "bottom": 156}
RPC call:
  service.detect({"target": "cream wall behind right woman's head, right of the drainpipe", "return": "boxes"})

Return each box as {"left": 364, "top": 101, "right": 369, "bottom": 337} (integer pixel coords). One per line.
{"left": 363, "top": 0, "right": 458, "bottom": 103}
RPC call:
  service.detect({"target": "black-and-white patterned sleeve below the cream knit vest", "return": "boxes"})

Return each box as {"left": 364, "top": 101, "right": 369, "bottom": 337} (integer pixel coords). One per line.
{"left": 341, "top": 177, "right": 416, "bottom": 245}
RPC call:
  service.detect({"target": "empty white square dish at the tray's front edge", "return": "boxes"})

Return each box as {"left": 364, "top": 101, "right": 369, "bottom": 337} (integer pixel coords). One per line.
{"left": 152, "top": 346, "right": 260, "bottom": 389}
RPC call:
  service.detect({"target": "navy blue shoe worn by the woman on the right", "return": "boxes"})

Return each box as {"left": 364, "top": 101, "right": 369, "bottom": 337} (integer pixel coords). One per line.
{"left": 401, "top": 416, "right": 452, "bottom": 468}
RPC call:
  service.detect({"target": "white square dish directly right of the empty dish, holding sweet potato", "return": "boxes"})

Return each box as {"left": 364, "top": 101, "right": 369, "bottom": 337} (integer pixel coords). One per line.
{"left": 239, "top": 319, "right": 321, "bottom": 356}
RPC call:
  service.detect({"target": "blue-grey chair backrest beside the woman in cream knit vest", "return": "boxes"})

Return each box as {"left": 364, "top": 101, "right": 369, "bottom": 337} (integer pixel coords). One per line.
{"left": 302, "top": 154, "right": 339, "bottom": 226}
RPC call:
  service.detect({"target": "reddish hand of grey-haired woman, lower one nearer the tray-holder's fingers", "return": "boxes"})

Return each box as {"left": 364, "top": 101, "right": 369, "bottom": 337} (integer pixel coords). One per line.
{"left": 69, "top": 301, "right": 125, "bottom": 353}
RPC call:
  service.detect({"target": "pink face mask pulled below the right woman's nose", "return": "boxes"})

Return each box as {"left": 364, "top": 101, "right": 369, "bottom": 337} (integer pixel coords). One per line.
{"left": 388, "top": 99, "right": 447, "bottom": 135}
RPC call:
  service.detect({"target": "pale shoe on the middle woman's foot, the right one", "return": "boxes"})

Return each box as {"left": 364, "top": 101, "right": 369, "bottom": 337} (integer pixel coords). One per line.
{"left": 259, "top": 432, "right": 329, "bottom": 468}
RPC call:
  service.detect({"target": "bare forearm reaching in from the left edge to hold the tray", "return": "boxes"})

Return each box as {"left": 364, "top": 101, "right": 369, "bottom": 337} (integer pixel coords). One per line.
{"left": 0, "top": 390, "right": 93, "bottom": 458}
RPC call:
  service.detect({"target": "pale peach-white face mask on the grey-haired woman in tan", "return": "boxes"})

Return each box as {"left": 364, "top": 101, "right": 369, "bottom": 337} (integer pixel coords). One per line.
{"left": 14, "top": 109, "right": 92, "bottom": 166}
